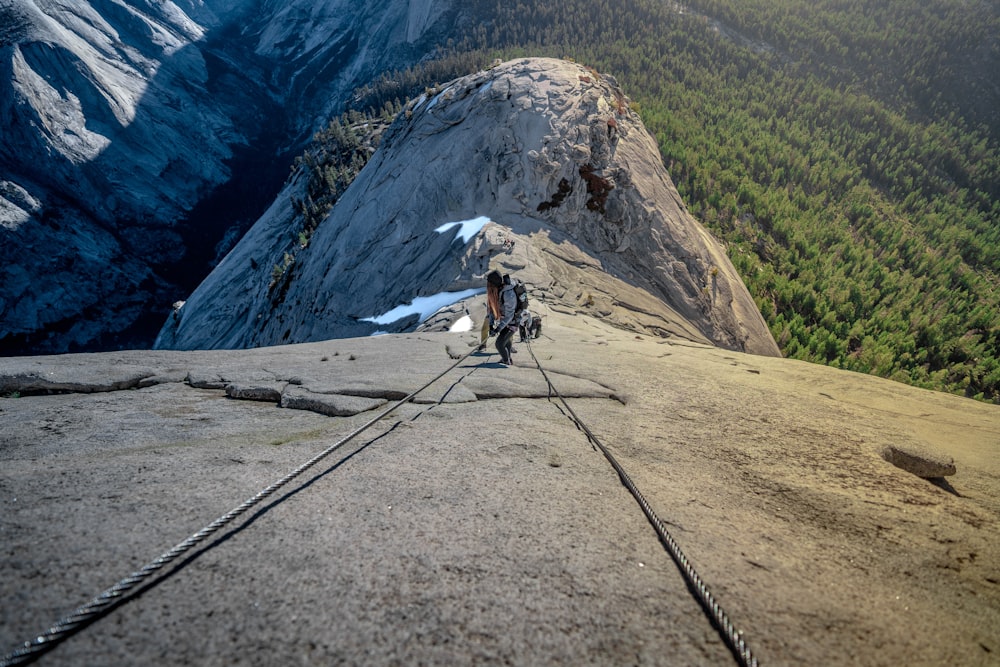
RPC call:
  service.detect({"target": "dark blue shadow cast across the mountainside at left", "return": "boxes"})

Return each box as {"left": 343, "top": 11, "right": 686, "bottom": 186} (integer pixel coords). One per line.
{"left": 0, "top": 11, "right": 294, "bottom": 356}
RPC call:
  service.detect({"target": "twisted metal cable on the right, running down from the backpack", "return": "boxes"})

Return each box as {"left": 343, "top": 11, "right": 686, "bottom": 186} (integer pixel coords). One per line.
{"left": 526, "top": 342, "right": 758, "bottom": 667}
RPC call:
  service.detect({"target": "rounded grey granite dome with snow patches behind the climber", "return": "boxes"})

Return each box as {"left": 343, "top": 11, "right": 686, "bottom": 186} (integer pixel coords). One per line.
{"left": 157, "top": 59, "right": 778, "bottom": 355}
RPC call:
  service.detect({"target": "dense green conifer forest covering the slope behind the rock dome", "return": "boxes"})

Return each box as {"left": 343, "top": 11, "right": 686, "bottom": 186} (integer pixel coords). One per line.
{"left": 342, "top": 0, "right": 1000, "bottom": 402}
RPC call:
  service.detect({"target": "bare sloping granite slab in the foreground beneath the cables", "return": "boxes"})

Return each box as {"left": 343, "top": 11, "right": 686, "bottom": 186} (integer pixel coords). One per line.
{"left": 0, "top": 320, "right": 1000, "bottom": 667}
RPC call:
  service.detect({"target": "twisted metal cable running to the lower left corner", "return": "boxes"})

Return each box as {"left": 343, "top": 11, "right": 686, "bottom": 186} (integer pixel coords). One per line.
{"left": 0, "top": 348, "right": 478, "bottom": 667}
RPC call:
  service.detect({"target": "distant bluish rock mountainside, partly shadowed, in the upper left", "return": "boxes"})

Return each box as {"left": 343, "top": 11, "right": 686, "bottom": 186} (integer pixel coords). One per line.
{"left": 0, "top": 0, "right": 468, "bottom": 354}
